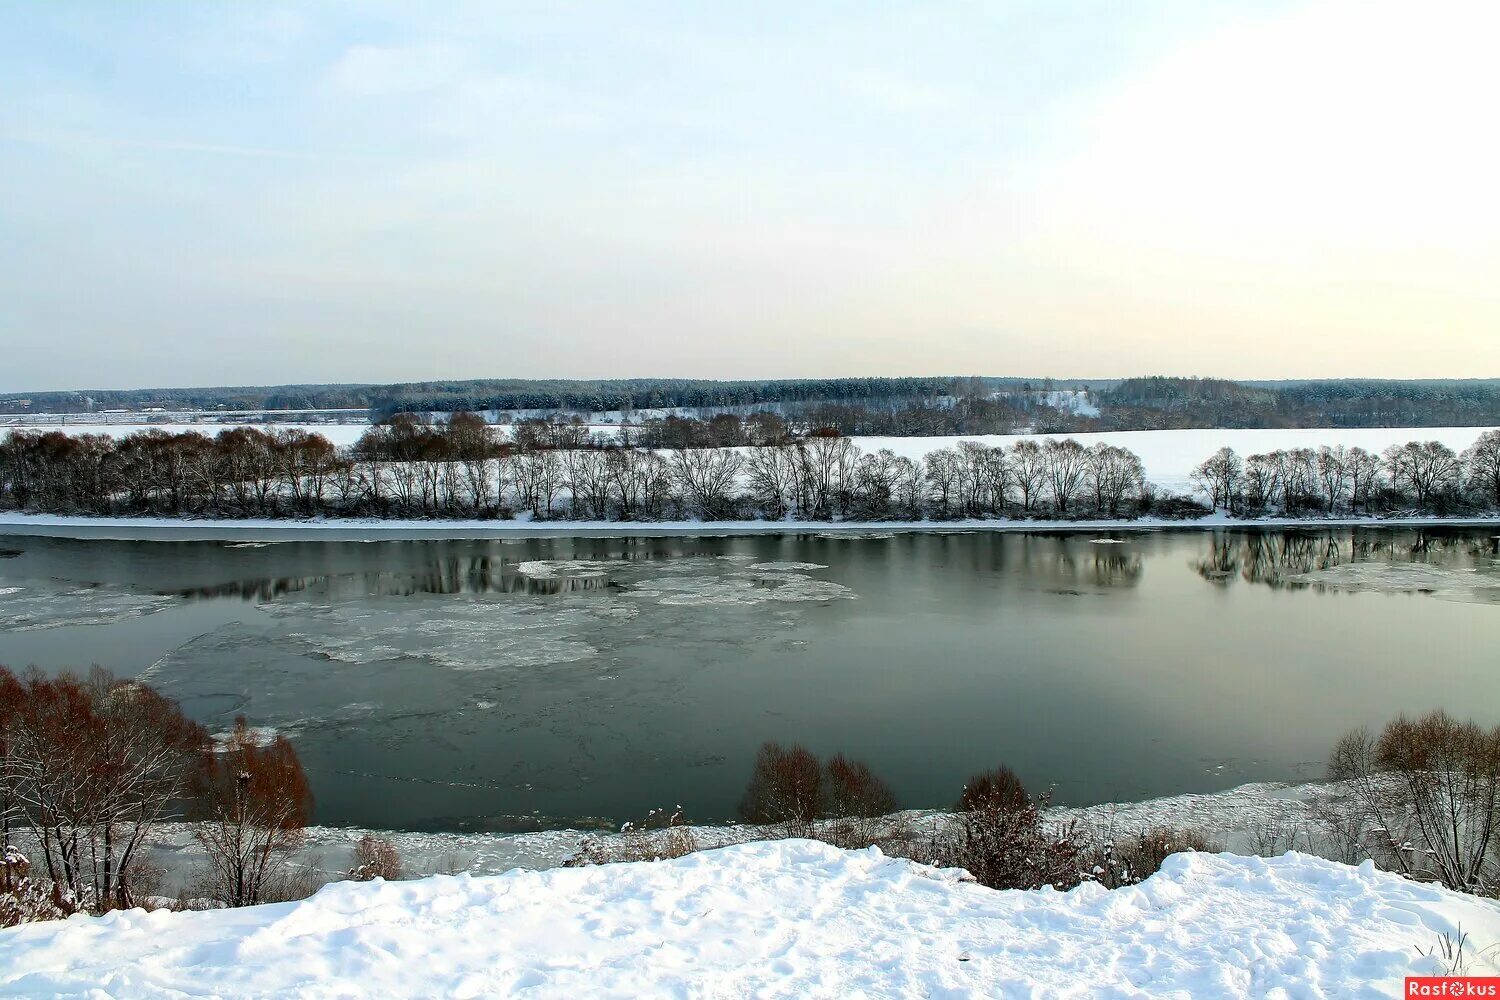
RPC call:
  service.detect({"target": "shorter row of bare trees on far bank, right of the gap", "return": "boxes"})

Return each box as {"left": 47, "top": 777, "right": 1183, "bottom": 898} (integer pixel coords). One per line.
{"left": 1193, "top": 430, "right": 1500, "bottom": 517}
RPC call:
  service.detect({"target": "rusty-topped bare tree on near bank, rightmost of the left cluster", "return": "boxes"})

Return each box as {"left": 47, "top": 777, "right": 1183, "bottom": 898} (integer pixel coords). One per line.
{"left": 194, "top": 715, "right": 312, "bottom": 906}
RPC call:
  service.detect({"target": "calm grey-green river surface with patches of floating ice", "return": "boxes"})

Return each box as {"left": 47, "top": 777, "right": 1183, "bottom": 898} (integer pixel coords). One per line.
{"left": 0, "top": 529, "right": 1500, "bottom": 831}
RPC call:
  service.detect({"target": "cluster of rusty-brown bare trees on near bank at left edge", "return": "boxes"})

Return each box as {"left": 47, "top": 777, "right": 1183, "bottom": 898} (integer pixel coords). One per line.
{"left": 0, "top": 667, "right": 312, "bottom": 916}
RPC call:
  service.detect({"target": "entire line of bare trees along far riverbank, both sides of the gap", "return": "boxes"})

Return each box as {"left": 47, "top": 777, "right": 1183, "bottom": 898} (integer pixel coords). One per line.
{"left": 0, "top": 414, "right": 1500, "bottom": 520}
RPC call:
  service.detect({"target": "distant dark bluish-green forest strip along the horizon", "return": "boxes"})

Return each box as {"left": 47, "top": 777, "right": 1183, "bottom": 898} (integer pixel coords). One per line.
{"left": 0, "top": 376, "right": 1500, "bottom": 435}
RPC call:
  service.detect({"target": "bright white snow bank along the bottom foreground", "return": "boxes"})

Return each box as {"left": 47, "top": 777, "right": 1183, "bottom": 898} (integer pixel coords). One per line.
{"left": 0, "top": 841, "right": 1500, "bottom": 997}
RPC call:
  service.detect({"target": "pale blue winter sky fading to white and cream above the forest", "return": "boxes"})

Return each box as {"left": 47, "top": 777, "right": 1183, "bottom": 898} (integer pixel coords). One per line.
{"left": 0, "top": 0, "right": 1500, "bottom": 390}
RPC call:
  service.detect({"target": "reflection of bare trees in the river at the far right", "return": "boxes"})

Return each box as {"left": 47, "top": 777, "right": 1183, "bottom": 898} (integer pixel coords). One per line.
{"left": 1191, "top": 528, "right": 1500, "bottom": 589}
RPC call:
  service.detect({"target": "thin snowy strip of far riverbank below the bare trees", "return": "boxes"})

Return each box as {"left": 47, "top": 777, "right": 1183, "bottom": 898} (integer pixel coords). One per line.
{"left": 0, "top": 511, "right": 1500, "bottom": 541}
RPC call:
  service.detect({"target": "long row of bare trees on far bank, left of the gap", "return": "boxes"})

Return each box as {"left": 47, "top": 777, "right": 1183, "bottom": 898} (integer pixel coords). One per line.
{"left": 0, "top": 414, "right": 1149, "bottom": 520}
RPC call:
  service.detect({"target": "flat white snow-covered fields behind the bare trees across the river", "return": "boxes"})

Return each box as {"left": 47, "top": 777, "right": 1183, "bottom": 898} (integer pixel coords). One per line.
{"left": 20, "top": 424, "right": 1491, "bottom": 492}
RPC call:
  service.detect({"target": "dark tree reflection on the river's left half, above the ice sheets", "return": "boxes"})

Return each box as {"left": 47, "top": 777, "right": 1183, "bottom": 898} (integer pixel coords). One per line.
{"left": 171, "top": 556, "right": 609, "bottom": 601}
